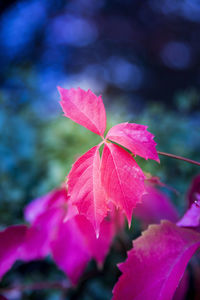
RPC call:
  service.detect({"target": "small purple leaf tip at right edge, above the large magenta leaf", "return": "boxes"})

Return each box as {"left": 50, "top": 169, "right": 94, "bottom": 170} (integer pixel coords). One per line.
{"left": 177, "top": 197, "right": 200, "bottom": 227}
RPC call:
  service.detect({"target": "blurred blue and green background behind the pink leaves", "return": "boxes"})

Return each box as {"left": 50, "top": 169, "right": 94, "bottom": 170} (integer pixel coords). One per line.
{"left": 0, "top": 0, "right": 200, "bottom": 300}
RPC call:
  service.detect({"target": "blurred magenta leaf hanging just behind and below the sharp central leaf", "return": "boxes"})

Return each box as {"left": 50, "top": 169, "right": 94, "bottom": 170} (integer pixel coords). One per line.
{"left": 21, "top": 188, "right": 112, "bottom": 284}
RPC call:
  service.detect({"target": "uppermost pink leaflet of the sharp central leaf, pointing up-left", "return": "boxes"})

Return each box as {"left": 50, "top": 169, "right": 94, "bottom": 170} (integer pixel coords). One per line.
{"left": 58, "top": 87, "right": 106, "bottom": 136}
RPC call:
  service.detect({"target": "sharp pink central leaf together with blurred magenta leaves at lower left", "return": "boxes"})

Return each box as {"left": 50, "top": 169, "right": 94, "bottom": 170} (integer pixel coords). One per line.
{"left": 0, "top": 88, "right": 159, "bottom": 283}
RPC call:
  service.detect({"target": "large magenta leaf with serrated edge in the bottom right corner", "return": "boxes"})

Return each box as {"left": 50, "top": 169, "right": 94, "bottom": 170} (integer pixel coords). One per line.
{"left": 113, "top": 221, "right": 200, "bottom": 300}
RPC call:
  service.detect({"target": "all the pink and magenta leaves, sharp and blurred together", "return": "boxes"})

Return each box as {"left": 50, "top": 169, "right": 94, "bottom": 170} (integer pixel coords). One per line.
{"left": 0, "top": 88, "right": 200, "bottom": 300}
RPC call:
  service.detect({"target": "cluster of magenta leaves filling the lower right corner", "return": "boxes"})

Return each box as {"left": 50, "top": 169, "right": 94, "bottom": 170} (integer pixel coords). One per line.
{"left": 113, "top": 176, "right": 200, "bottom": 300}
